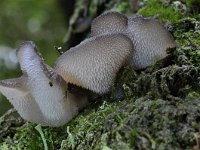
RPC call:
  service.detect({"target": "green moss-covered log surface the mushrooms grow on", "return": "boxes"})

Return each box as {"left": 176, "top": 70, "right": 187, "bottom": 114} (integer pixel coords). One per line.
{"left": 0, "top": 0, "right": 200, "bottom": 150}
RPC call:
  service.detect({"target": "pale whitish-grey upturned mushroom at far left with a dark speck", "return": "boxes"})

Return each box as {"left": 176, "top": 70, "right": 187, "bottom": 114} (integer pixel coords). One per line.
{"left": 0, "top": 41, "right": 87, "bottom": 126}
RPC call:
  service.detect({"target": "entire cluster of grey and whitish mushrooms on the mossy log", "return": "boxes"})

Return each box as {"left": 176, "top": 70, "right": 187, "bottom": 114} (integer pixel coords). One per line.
{"left": 0, "top": 12, "right": 176, "bottom": 126}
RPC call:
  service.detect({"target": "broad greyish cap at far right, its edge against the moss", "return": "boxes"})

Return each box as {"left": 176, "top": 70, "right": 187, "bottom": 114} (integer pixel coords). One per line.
{"left": 125, "top": 17, "right": 176, "bottom": 69}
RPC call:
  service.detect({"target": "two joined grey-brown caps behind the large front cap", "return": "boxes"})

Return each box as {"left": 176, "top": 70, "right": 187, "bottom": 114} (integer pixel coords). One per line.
{"left": 91, "top": 12, "right": 176, "bottom": 69}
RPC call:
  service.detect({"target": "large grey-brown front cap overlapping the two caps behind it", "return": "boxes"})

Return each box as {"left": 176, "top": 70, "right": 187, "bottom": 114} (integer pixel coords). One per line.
{"left": 55, "top": 34, "right": 133, "bottom": 94}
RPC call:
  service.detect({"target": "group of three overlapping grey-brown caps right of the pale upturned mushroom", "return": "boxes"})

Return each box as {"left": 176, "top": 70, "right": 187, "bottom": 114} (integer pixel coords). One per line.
{"left": 55, "top": 12, "right": 176, "bottom": 94}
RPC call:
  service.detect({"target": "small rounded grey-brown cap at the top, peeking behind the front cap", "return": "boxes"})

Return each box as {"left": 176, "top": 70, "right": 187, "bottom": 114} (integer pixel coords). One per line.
{"left": 91, "top": 12, "right": 128, "bottom": 36}
